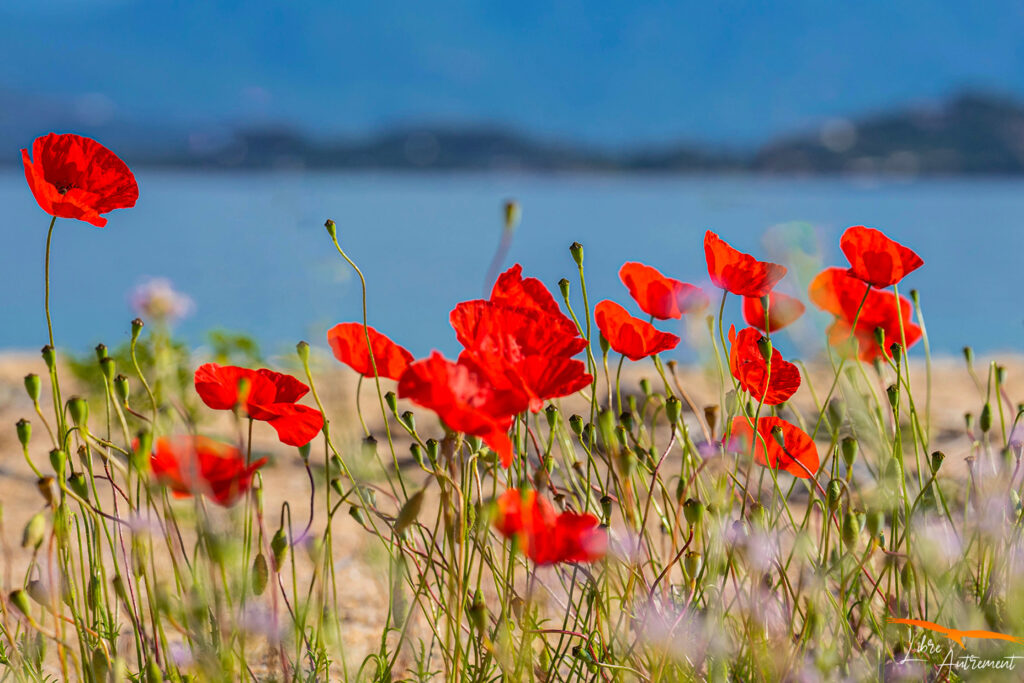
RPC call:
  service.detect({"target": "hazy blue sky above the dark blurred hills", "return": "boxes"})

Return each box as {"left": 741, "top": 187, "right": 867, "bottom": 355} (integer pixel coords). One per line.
{"left": 0, "top": 0, "right": 1024, "bottom": 145}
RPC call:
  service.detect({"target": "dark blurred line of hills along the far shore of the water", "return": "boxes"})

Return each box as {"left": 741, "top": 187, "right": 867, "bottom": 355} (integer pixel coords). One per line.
{"left": 6, "top": 93, "right": 1024, "bottom": 175}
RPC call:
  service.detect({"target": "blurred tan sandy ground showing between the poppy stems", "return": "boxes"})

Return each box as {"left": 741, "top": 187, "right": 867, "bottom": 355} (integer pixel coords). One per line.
{"left": 0, "top": 353, "right": 1024, "bottom": 679}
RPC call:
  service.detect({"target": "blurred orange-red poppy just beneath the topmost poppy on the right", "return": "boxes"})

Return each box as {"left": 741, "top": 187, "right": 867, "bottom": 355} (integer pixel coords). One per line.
{"left": 808, "top": 267, "right": 922, "bottom": 362}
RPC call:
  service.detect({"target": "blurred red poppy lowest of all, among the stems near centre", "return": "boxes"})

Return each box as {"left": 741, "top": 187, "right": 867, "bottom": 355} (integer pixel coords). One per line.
{"left": 495, "top": 488, "right": 608, "bottom": 564}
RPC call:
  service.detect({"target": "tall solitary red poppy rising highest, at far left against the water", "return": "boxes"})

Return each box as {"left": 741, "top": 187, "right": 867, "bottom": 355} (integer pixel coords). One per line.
{"left": 22, "top": 133, "right": 138, "bottom": 227}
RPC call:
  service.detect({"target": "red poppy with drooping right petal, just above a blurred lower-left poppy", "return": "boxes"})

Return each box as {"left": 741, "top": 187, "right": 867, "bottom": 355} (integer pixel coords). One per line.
{"left": 196, "top": 362, "right": 324, "bottom": 446}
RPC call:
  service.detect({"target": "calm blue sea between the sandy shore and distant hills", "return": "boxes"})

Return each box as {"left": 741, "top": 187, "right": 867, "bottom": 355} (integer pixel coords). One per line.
{"left": 0, "top": 169, "right": 1024, "bottom": 358}
